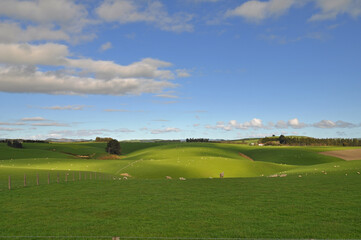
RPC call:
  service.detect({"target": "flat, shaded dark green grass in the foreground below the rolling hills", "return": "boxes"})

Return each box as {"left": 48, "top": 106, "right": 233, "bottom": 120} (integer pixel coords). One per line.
{"left": 0, "top": 173, "right": 361, "bottom": 239}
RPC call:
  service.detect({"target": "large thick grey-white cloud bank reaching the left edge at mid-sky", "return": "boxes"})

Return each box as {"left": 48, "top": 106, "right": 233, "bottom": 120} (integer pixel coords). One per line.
{"left": 0, "top": 43, "right": 176, "bottom": 95}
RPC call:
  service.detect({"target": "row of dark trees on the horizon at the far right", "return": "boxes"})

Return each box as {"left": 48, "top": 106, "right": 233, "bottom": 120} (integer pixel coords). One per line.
{"left": 260, "top": 135, "right": 361, "bottom": 146}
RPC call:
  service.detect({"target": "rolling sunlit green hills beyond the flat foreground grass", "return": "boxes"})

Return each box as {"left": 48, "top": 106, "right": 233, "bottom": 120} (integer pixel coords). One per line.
{"left": 0, "top": 142, "right": 361, "bottom": 185}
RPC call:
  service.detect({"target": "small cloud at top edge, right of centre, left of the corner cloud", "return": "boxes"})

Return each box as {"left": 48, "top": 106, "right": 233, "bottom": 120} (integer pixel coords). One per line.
{"left": 226, "top": 0, "right": 296, "bottom": 21}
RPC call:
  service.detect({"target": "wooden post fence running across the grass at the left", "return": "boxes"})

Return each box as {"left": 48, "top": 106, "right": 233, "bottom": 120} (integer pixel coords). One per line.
{"left": 0, "top": 171, "right": 114, "bottom": 191}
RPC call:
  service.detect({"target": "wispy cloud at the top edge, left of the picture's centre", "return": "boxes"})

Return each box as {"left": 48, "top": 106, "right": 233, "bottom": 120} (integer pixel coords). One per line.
{"left": 96, "top": 0, "right": 193, "bottom": 32}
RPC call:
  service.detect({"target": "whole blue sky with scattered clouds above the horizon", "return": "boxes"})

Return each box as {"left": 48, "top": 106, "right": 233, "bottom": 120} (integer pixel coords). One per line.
{"left": 0, "top": 0, "right": 361, "bottom": 140}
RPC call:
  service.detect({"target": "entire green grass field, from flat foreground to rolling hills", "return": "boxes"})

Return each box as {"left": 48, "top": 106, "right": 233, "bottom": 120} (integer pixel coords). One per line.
{"left": 0, "top": 142, "right": 361, "bottom": 239}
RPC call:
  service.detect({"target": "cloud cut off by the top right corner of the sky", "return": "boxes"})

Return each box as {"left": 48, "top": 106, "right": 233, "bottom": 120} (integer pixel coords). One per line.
{"left": 309, "top": 0, "right": 361, "bottom": 21}
